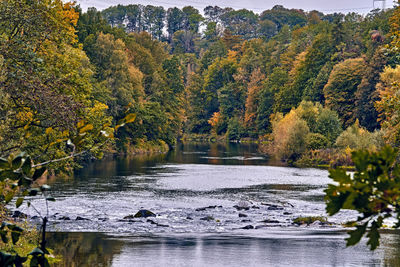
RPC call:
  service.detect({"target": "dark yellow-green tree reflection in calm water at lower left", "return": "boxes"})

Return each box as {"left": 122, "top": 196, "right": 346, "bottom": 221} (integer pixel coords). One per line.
{"left": 48, "top": 233, "right": 124, "bottom": 267}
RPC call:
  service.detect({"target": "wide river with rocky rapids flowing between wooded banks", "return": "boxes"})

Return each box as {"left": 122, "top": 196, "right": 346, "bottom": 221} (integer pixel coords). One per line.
{"left": 22, "top": 144, "right": 400, "bottom": 267}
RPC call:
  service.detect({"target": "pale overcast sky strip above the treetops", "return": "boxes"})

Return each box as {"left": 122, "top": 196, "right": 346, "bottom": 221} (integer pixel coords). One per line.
{"left": 76, "top": 0, "right": 393, "bottom": 14}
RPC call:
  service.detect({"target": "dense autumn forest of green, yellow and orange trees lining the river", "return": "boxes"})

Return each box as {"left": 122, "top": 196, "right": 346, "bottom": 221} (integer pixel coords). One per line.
{"left": 0, "top": 0, "right": 400, "bottom": 168}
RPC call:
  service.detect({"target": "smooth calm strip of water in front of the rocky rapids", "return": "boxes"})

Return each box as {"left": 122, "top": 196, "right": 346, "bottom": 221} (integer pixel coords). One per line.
{"left": 49, "top": 232, "right": 400, "bottom": 267}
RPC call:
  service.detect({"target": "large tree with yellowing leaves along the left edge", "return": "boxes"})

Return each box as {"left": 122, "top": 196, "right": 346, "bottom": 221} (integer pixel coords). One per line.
{"left": 0, "top": 0, "right": 112, "bottom": 164}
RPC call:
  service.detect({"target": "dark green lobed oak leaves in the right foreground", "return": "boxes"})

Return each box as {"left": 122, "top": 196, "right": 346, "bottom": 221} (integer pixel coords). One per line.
{"left": 325, "top": 146, "right": 400, "bottom": 250}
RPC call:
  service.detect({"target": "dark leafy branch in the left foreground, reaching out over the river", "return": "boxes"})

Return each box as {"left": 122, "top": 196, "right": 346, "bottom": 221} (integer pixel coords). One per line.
{"left": 0, "top": 114, "right": 136, "bottom": 267}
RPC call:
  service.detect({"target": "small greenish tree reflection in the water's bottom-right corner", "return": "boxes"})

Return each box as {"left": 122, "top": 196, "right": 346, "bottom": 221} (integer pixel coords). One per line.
{"left": 381, "top": 231, "right": 400, "bottom": 266}
